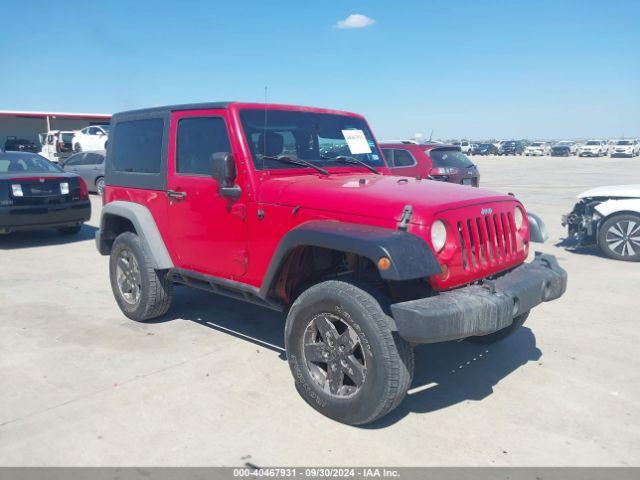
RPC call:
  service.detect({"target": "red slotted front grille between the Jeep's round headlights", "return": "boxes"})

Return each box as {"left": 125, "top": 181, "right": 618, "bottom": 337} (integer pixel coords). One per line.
{"left": 456, "top": 212, "right": 517, "bottom": 272}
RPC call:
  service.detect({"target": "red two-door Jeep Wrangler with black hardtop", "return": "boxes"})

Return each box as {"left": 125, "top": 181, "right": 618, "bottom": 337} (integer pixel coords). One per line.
{"left": 96, "top": 103, "right": 567, "bottom": 424}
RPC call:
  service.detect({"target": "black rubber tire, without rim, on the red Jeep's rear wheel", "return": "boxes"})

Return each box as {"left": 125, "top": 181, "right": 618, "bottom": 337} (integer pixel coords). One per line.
{"left": 109, "top": 232, "right": 173, "bottom": 322}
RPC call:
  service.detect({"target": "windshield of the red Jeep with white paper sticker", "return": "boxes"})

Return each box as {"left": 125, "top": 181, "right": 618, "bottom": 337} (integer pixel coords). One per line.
{"left": 240, "top": 110, "right": 384, "bottom": 170}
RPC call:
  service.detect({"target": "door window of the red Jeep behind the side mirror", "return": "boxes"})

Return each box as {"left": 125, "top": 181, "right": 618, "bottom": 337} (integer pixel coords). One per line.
{"left": 176, "top": 117, "right": 231, "bottom": 175}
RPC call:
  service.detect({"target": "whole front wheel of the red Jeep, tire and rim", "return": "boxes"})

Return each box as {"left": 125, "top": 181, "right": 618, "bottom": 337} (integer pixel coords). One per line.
{"left": 285, "top": 280, "right": 414, "bottom": 425}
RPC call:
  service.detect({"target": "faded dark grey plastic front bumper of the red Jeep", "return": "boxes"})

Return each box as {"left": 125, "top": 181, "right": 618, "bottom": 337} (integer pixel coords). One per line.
{"left": 391, "top": 252, "right": 567, "bottom": 343}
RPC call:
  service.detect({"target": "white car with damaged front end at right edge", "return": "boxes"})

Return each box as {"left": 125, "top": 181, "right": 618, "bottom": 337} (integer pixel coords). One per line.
{"left": 562, "top": 184, "right": 640, "bottom": 262}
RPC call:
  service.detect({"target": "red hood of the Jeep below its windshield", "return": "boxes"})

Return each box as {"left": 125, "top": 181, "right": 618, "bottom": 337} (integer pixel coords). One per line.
{"left": 260, "top": 174, "right": 515, "bottom": 223}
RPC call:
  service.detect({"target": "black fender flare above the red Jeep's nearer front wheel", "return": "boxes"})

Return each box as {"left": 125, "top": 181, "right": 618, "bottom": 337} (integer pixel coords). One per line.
{"left": 260, "top": 220, "right": 442, "bottom": 298}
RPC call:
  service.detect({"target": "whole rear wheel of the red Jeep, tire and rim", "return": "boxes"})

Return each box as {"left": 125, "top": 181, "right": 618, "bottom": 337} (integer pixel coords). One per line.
{"left": 109, "top": 232, "right": 173, "bottom": 322}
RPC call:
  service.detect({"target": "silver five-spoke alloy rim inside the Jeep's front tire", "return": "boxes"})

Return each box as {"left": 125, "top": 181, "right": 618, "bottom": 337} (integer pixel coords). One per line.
{"left": 302, "top": 313, "right": 367, "bottom": 398}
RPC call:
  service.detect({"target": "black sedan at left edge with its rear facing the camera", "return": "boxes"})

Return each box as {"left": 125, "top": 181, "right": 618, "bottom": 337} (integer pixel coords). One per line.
{"left": 0, "top": 152, "right": 91, "bottom": 234}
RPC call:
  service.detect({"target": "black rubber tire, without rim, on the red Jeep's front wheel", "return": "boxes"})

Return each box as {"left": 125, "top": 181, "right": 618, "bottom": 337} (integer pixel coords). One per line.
{"left": 285, "top": 280, "right": 414, "bottom": 425}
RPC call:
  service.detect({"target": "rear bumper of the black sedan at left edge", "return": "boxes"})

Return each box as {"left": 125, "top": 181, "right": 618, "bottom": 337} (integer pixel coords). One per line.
{"left": 0, "top": 200, "right": 91, "bottom": 233}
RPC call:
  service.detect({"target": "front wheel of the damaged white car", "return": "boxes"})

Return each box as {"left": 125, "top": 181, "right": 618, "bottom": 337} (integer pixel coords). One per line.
{"left": 598, "top": 213, "right": 640, "bottom": 262}
